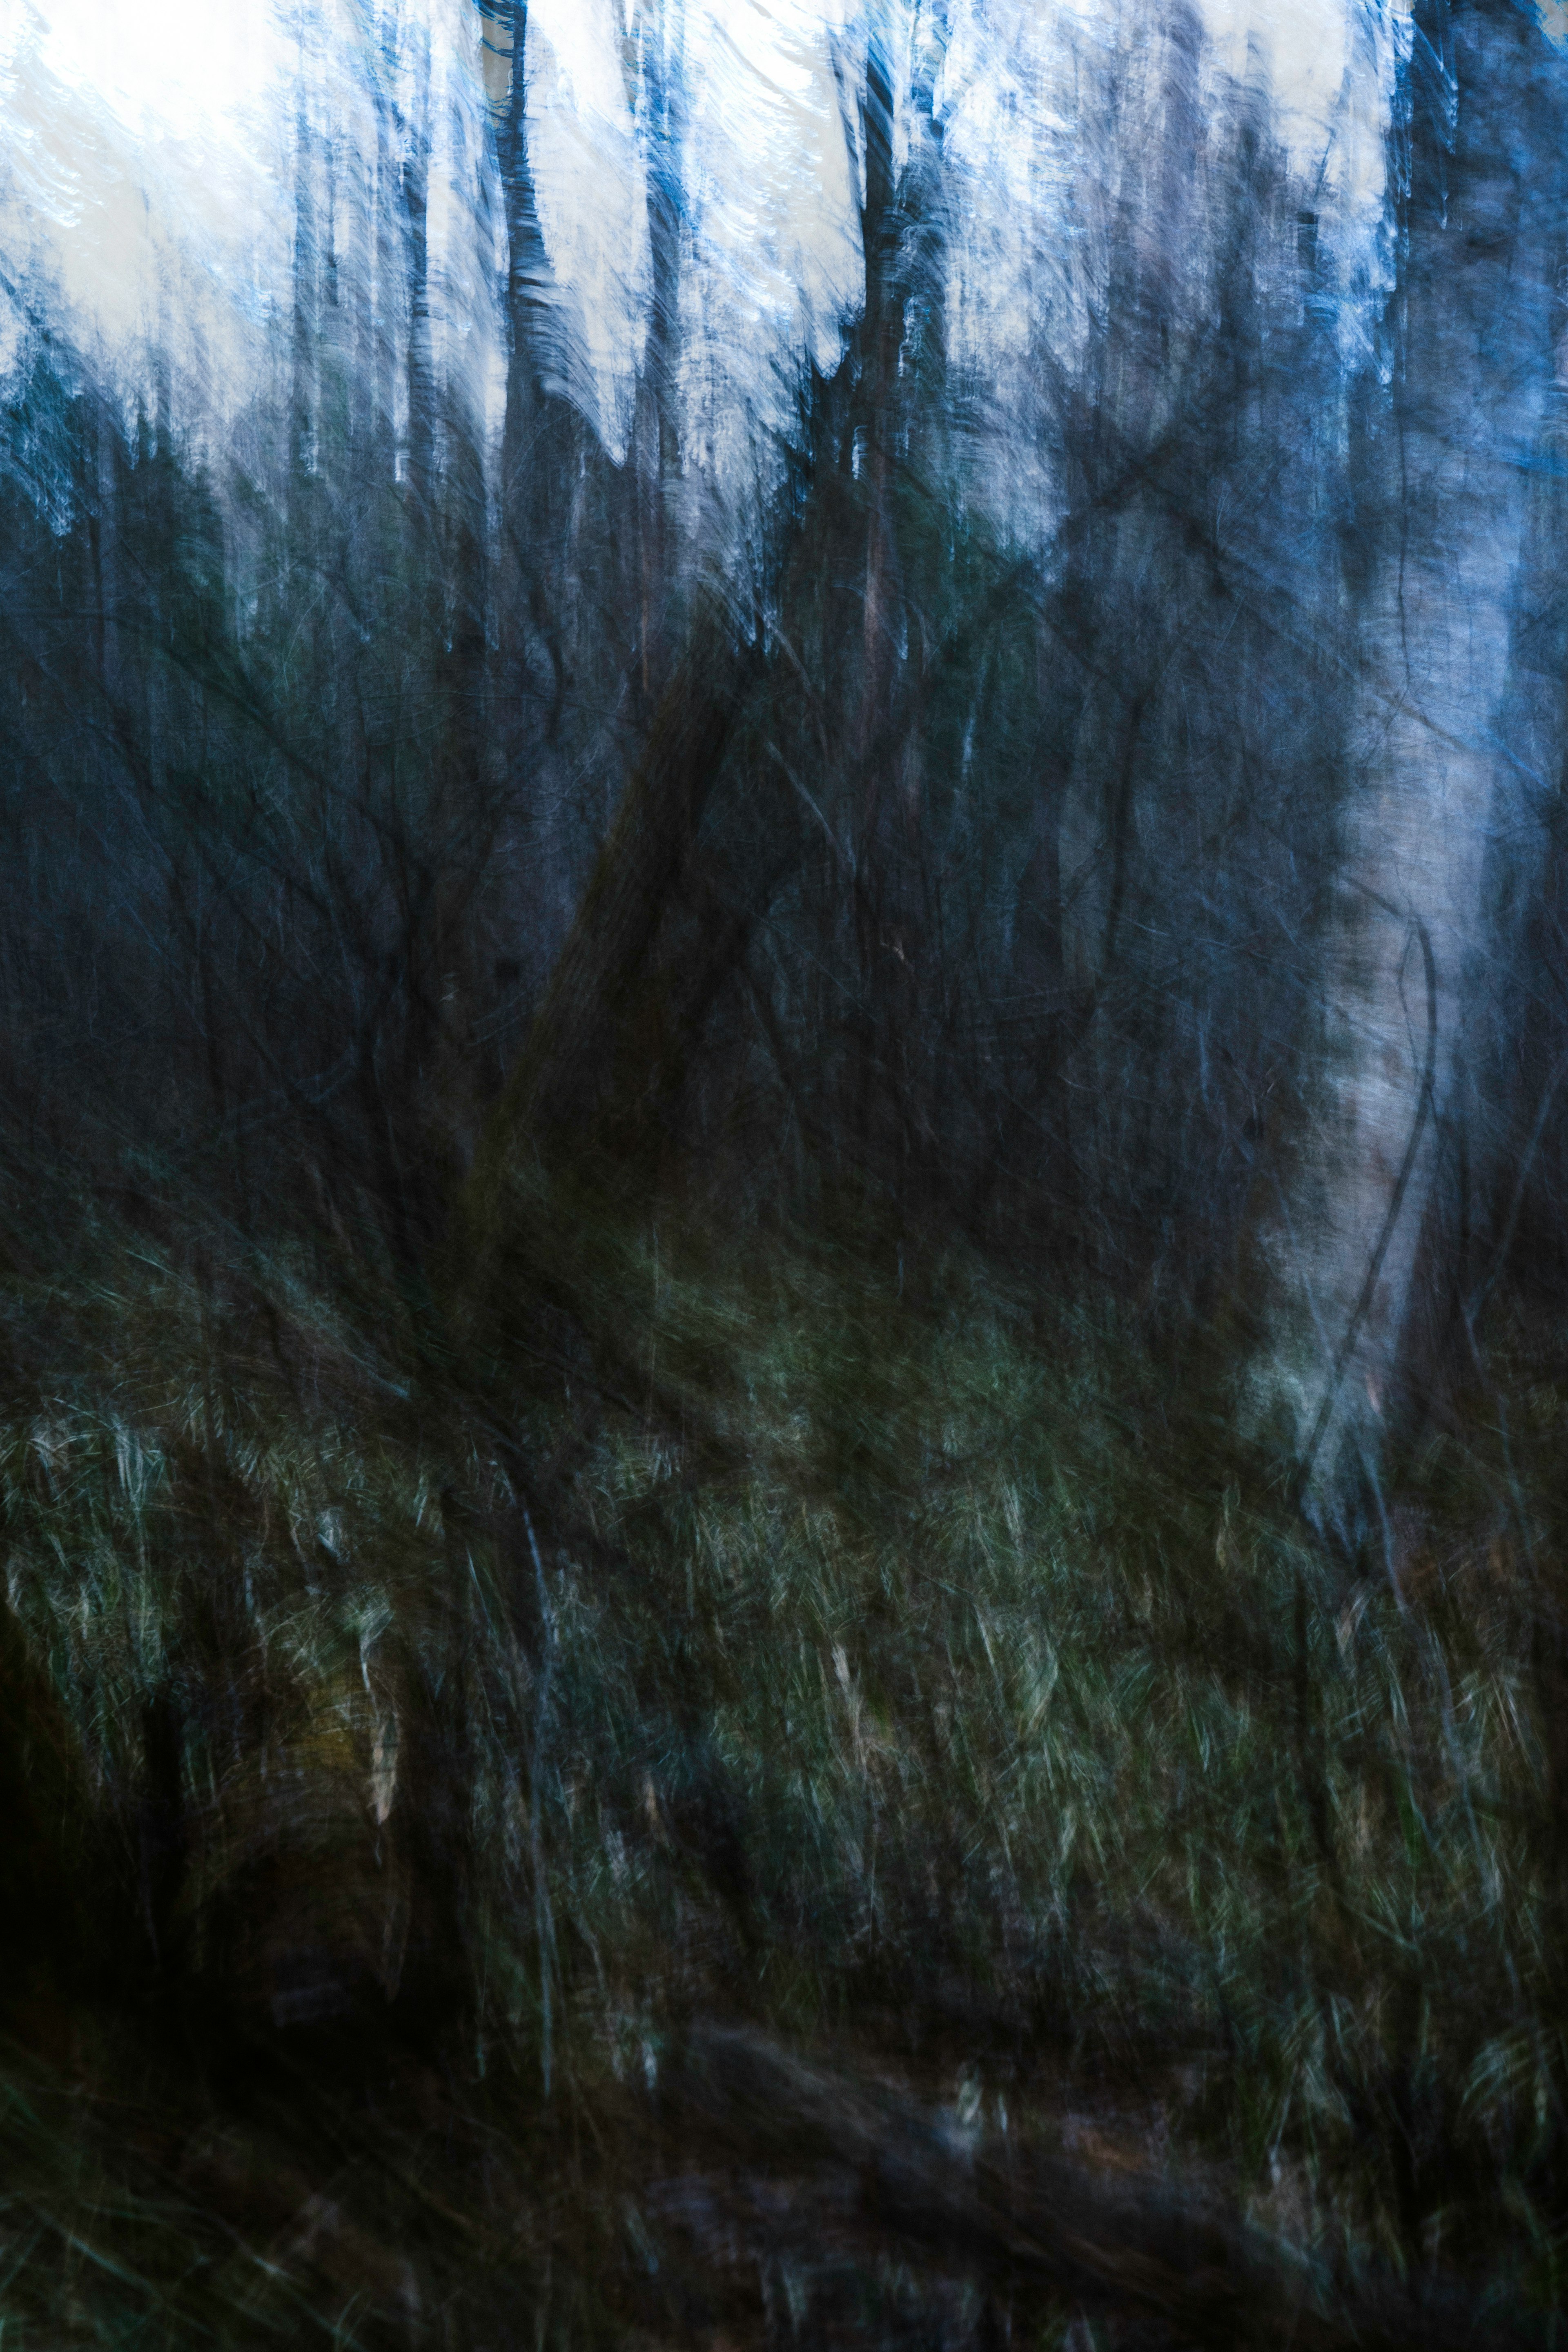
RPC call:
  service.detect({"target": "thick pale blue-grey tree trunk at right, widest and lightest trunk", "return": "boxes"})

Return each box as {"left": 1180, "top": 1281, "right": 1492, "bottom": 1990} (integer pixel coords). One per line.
{"left": 1255, "top": 5, "right": 1561, "bottom": 1529}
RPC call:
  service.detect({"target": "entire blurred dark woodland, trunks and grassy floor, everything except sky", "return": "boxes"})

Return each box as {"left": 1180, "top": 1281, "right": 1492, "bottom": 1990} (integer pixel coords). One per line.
{"left": 0, "top": 0, "right": 1568, "bottom": 2352}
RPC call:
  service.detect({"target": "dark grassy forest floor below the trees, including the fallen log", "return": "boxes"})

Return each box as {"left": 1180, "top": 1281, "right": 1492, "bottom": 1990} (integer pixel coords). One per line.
{"left": 0, "top": 1183, "right": 1568, "bottom": 2352}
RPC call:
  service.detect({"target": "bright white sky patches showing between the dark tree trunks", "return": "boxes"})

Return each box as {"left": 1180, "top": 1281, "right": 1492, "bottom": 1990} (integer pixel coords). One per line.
{"left": 0, "top": 0, "right": 1410, "bottom": 463}
